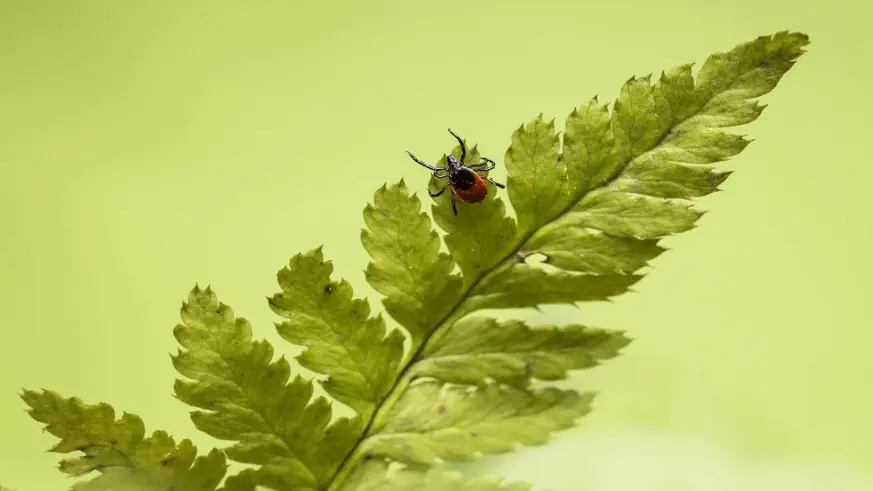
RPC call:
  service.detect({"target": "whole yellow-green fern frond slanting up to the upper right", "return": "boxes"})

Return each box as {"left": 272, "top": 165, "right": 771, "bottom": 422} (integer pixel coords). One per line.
{"left": 22, "top": 32, "right": 809, "bottom": 491}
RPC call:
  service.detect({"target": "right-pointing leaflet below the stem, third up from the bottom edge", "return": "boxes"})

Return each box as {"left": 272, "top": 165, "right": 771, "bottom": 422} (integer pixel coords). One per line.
{"left": 414, "top": 317, "right": 630, "bottom": 386}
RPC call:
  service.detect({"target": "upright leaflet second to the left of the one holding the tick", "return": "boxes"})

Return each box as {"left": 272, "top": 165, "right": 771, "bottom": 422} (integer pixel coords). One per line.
{"left": 270, "top": 248, "right": 404, "bottom": 420}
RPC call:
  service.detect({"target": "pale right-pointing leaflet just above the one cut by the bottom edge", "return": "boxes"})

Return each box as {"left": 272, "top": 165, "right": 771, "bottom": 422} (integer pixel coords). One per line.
{"left": 362, "top": 380, "right": 593, "bottom": 465}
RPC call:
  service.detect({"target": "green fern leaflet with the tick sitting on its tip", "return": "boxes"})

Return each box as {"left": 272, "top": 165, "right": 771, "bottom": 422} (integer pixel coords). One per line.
{"left": 428, "top": 139, "right": 516, "bottom": 287}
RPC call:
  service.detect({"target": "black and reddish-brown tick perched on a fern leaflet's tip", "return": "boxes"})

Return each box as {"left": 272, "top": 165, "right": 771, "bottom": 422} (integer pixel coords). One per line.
{"left": 406, "top": 129, "right": 506, "bottom": 215}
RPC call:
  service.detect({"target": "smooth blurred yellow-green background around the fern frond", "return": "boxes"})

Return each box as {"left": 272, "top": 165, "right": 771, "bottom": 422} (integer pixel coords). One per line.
{"left": 0, "top": 0, "right": 873, "bottom": 491}
